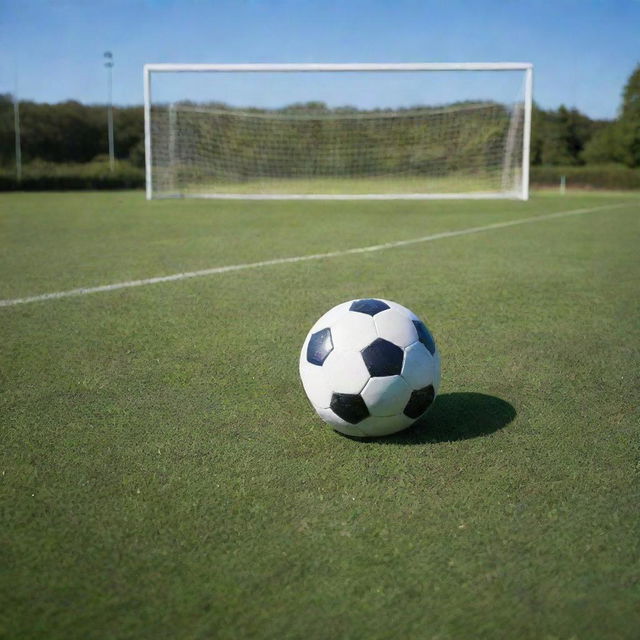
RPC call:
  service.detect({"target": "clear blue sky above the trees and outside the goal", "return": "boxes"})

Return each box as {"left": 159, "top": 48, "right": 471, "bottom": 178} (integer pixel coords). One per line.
{"left": 0, "top": 0, "right": 640, "bottom": 118}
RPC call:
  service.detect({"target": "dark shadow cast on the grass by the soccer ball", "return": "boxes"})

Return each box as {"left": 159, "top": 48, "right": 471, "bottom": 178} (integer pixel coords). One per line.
{"left": 358, "top": 392, "right": 516, "bottom": 444}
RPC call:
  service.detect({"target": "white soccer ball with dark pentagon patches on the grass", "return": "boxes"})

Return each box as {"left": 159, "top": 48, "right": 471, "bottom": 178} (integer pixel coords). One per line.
{"left": 300, "top": 298, "right": 440, "bottom": 438}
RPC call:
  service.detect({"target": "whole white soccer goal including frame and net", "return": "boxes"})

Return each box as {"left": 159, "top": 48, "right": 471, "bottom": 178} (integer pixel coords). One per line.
{"left": 144, "top": 62, "right": 533, "bottom": 200}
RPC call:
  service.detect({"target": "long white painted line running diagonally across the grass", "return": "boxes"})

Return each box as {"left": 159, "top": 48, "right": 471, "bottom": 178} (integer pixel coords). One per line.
{"left": 0, "top": 203, "right": 628, "bottom": 307}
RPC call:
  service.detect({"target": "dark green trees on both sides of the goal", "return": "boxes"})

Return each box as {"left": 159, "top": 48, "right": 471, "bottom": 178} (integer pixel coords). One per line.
{"left": 0, "top": 65, "right": 640, "bottom": 169}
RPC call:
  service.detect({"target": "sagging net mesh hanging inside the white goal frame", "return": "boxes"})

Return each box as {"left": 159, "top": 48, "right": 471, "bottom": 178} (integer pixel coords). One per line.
{"left": 151, "top": 84, "right": 524, "bottom": 196}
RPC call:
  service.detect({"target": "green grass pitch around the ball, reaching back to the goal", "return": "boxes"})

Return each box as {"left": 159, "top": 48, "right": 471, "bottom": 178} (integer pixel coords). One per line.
{"left": 0, "top": 192, "right": 640, "bottom": 640}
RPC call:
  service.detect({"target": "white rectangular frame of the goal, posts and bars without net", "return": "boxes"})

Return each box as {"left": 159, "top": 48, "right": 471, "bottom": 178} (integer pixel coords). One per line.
{"left": 143, "top": 62, "right": 533, "bottom": 200}
